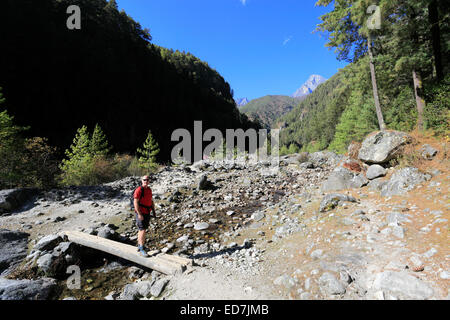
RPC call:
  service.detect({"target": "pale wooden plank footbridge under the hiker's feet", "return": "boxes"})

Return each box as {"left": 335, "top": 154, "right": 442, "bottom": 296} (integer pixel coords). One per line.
{"left": 62, "top": 231, "right": 186, "bottom": 274}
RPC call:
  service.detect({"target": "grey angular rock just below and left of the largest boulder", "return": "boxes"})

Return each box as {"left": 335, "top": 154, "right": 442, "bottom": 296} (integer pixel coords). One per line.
{"left": 321, "top": 166, "right": 369, "bottom": 192}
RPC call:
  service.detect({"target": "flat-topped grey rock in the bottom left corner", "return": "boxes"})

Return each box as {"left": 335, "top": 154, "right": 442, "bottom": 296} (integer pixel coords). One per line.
{"left": 0, "top": 278, "right": 56, "bottom": 300}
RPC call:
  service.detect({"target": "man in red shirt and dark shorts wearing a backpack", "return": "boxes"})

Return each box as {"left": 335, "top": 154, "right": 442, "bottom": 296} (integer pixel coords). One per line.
{"left": 133, "top": 176, "right": 156, "bottom": 257}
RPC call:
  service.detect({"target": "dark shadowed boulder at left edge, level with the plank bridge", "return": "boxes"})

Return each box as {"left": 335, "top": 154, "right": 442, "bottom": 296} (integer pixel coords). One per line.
{"left": 0, "top": 229, "right": 29, "bottom": 276}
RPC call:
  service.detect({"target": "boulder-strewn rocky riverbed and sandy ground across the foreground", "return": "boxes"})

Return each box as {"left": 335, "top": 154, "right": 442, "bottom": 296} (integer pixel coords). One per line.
{"left": 0, "top": 131, "right": 450, "bottom": 299}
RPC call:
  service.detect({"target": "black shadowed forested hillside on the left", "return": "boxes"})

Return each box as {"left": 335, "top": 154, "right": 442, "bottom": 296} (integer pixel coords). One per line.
{"left": 0, "top": 0, "right": 254, "bottom": 160}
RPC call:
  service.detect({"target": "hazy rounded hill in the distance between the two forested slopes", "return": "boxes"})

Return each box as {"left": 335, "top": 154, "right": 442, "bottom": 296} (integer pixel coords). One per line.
{"left": 239, "top": 95, "right": 299, "bottom": 129}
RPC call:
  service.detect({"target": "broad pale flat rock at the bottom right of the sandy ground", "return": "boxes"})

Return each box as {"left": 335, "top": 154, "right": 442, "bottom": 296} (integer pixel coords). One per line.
{"left": 373, "top": 271, "right": 433, "bottom": 300}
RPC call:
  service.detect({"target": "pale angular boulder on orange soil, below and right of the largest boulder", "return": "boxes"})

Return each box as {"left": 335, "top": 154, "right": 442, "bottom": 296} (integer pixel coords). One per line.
{"left": 381, "top": 167, "right": 431, "bottom": 197}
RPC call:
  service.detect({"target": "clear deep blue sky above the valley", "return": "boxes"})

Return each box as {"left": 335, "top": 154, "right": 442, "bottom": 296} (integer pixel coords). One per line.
{"left": 117, "top": 0, "right": 345, "bottom": 100}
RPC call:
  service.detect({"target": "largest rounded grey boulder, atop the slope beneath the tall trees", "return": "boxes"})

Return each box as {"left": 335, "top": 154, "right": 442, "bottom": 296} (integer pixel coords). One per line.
{"left": 358, "top": 130, "right": 412, "bottom": 163}
